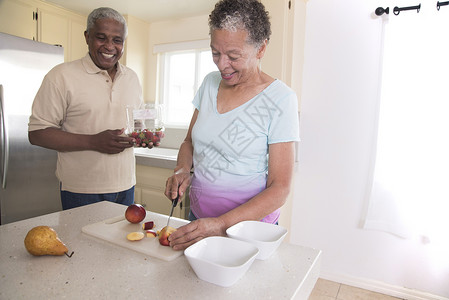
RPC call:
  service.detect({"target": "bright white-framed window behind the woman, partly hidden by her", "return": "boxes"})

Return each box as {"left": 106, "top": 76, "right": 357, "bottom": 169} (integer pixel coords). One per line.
{"left": 155, "top": 41, "right": 217, "bottom": 128}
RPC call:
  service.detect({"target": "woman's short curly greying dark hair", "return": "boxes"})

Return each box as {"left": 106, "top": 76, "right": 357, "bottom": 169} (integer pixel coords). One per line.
{"left": 209, "top": 0, "right": 271, "bottom": 47}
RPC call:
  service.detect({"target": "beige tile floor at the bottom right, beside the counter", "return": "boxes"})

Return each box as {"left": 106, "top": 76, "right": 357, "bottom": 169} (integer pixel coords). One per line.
{"left": 309, "top": 278, "right": 399, "bottom": 300}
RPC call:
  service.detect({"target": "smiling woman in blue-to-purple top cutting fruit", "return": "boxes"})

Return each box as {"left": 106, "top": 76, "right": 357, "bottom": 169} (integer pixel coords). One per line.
{"left": 165, "top": 0, "right": 299, "bottom": 250}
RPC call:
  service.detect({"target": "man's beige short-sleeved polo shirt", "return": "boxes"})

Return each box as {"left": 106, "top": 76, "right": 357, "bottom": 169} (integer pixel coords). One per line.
{"left": 28, "top": 54, "right": 142, "bottom": 194}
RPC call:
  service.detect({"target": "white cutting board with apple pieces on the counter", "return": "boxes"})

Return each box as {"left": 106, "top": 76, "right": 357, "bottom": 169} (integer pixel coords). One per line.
{"left": 81, "top": 211, "right": 189, "bottom": 261}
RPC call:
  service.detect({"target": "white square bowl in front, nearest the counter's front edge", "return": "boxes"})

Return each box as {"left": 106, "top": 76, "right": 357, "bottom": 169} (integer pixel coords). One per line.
{"left": 184, "top": 236, "right": 259, "bottom": 287}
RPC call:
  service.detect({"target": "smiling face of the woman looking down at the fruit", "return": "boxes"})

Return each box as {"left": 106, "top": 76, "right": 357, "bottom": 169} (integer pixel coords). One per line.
{"left": 210, "top": 29, "right": 265, "bottom": 86}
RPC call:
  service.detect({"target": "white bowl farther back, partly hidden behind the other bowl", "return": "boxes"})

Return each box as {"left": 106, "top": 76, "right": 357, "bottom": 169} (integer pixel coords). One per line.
{"left": 226, "top": 221, "right": 287, "bottom": 260}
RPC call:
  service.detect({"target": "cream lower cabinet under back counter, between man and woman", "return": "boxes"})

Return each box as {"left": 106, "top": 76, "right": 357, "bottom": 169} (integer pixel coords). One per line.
{"left": 134, "top": 165, "right": 189, "bottom": 219}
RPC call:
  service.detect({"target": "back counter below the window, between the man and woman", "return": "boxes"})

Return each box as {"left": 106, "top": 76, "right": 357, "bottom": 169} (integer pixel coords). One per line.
{"left": 134, "top": 147, "right": 179, "bottom": 169}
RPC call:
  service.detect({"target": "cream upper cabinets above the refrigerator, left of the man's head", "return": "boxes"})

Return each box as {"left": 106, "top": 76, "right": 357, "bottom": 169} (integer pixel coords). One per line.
{"left": 0, "top": 0, "right": 87, "bottom": 61}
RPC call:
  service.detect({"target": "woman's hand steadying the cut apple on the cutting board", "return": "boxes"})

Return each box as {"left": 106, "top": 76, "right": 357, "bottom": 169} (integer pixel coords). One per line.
{"left": 168, "top": 218, "right": 226, "bottom": 250}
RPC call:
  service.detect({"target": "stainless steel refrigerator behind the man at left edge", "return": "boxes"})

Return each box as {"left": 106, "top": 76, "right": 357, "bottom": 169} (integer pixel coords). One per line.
{"left": 0, "top": 33, "right": 64, "bottom": 224}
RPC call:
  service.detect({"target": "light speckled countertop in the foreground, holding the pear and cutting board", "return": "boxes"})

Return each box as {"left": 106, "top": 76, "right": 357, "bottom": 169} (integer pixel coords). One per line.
{"left": 0, "top": 202, "right": 321, "bottom": 300}
